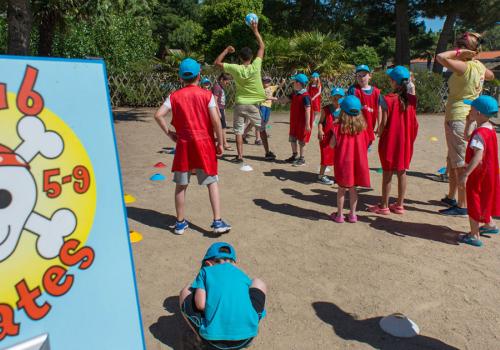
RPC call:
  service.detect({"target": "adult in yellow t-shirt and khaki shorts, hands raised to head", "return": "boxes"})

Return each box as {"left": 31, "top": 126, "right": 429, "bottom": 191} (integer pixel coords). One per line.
{"left": 436, "top": 32, "right": 494, "bottom": 216}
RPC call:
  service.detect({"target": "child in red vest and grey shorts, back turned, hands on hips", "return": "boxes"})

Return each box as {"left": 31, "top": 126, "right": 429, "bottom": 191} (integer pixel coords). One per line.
{"left": 155, "top": 58, "right": 231, "bottom": 235}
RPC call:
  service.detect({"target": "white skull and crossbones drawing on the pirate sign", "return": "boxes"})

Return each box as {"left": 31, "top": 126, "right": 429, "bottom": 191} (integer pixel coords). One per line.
{"left": 0, "top": 116, "right": 76, "bottom": 262}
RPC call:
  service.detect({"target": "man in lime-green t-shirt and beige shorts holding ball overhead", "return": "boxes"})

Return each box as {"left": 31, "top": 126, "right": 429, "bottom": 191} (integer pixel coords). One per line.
{"left": 214, "top": 22, "right": 276, "bottom": 163}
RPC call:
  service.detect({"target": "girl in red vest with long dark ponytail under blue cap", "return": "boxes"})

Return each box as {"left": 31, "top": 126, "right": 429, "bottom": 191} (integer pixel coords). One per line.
{"left": 369, "top": 66, "right": 418, "bottom": 215}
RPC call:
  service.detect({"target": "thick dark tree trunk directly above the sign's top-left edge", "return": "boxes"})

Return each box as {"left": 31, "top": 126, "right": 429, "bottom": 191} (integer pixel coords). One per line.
{"left": 7, "top": 0, "right": 32, "bottom": 55}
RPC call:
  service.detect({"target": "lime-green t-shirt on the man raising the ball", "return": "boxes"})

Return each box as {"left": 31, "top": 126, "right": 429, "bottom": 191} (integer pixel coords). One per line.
{"left": 224, "top": 57, "right": 266, "bottom": 105}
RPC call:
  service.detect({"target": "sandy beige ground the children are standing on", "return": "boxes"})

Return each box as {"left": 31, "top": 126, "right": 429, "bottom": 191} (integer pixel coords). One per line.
{"left": 115, "top": 109, "right": 500, "bottom": 350}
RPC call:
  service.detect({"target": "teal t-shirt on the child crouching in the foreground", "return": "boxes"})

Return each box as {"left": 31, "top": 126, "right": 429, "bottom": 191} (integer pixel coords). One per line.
{"left": 191, "top": 263, "right": 259, "bottom": 340}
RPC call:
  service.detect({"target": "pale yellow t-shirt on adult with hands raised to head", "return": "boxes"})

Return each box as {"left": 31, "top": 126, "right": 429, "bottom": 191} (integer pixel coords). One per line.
{"left": 446, "top": 60, "right": 486, "bottom": 121}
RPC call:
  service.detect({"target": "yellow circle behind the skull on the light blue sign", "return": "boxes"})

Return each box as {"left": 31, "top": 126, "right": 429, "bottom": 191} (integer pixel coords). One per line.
{"left": 0, "top": 93, "right": 96, "bottom": 308}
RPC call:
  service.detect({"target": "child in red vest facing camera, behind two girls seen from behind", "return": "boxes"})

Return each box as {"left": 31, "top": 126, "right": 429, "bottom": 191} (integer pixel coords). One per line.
{"left": 347, "top": 64, "right": 382, "bottom": 145}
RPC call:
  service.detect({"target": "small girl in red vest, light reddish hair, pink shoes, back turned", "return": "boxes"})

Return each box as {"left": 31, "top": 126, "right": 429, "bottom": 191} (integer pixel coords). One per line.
{"left": 330, "top": 96, "right": 370, "bottom": 223}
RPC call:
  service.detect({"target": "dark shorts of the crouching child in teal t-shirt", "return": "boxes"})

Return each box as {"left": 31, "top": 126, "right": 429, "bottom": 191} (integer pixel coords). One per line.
{"left": 181, "top": 288, "right": 266, "bottom": 350}
